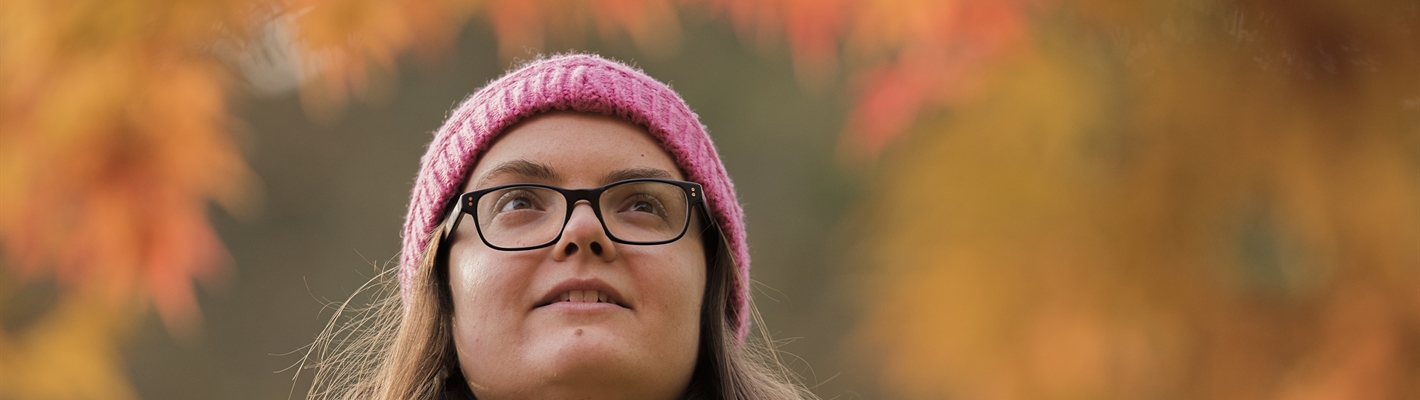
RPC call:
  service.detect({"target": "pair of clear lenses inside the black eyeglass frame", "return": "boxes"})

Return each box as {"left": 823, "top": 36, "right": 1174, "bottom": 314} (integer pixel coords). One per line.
{"left": 477, "top": 182, "right": 690, "bottom": 248}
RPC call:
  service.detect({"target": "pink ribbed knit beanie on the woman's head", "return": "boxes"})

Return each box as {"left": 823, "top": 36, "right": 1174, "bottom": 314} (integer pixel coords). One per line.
{"left": 399, "top": 54, "right": 750, "bottom": 340}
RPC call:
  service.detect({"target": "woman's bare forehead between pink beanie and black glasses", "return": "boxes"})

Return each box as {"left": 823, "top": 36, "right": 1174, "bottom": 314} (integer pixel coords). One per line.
{"left": 464, "top": 112, "right": 684, "bottom": 190}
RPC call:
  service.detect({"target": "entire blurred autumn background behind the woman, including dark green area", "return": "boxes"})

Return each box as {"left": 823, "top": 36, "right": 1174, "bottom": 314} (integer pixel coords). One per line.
{"left": 0, "top": 0, "right": 1420, "bottom": 400}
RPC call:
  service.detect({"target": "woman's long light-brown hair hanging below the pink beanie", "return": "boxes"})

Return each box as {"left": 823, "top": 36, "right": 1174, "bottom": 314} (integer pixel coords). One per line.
{"left": 300, "top": 224, "right": 817, "bottom": 400}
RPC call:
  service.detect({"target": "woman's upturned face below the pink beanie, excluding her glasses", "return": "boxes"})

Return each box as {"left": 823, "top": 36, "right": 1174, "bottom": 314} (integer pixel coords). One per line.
{"left": 449, "top": 112, "right": 706, "bottom": 399}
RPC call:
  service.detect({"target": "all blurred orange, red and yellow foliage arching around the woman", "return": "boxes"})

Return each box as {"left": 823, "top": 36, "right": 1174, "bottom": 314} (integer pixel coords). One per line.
{"left": 0, "top": 0, "right": 1420, "bottom": 399}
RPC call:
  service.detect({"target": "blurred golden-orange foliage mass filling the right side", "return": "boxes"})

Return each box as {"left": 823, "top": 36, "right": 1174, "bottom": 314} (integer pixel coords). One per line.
{"left": 861, "top": 1, "right": 1420, "bottom": 399}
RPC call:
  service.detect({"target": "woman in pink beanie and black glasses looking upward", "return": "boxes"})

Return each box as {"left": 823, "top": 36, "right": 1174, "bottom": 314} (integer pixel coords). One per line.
{"left": 310, "top": 55, "right": 812, "bottom": 399}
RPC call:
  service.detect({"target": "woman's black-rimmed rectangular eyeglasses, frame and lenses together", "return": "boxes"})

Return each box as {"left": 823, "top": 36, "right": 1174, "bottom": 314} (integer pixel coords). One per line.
{"left": 444, "top": 179, "right": 706, "bottom": 251}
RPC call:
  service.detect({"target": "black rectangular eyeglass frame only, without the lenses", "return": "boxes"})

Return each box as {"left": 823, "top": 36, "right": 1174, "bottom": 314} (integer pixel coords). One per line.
{"left": 443, "top": 177, "right": 714, "bottom": 251}
